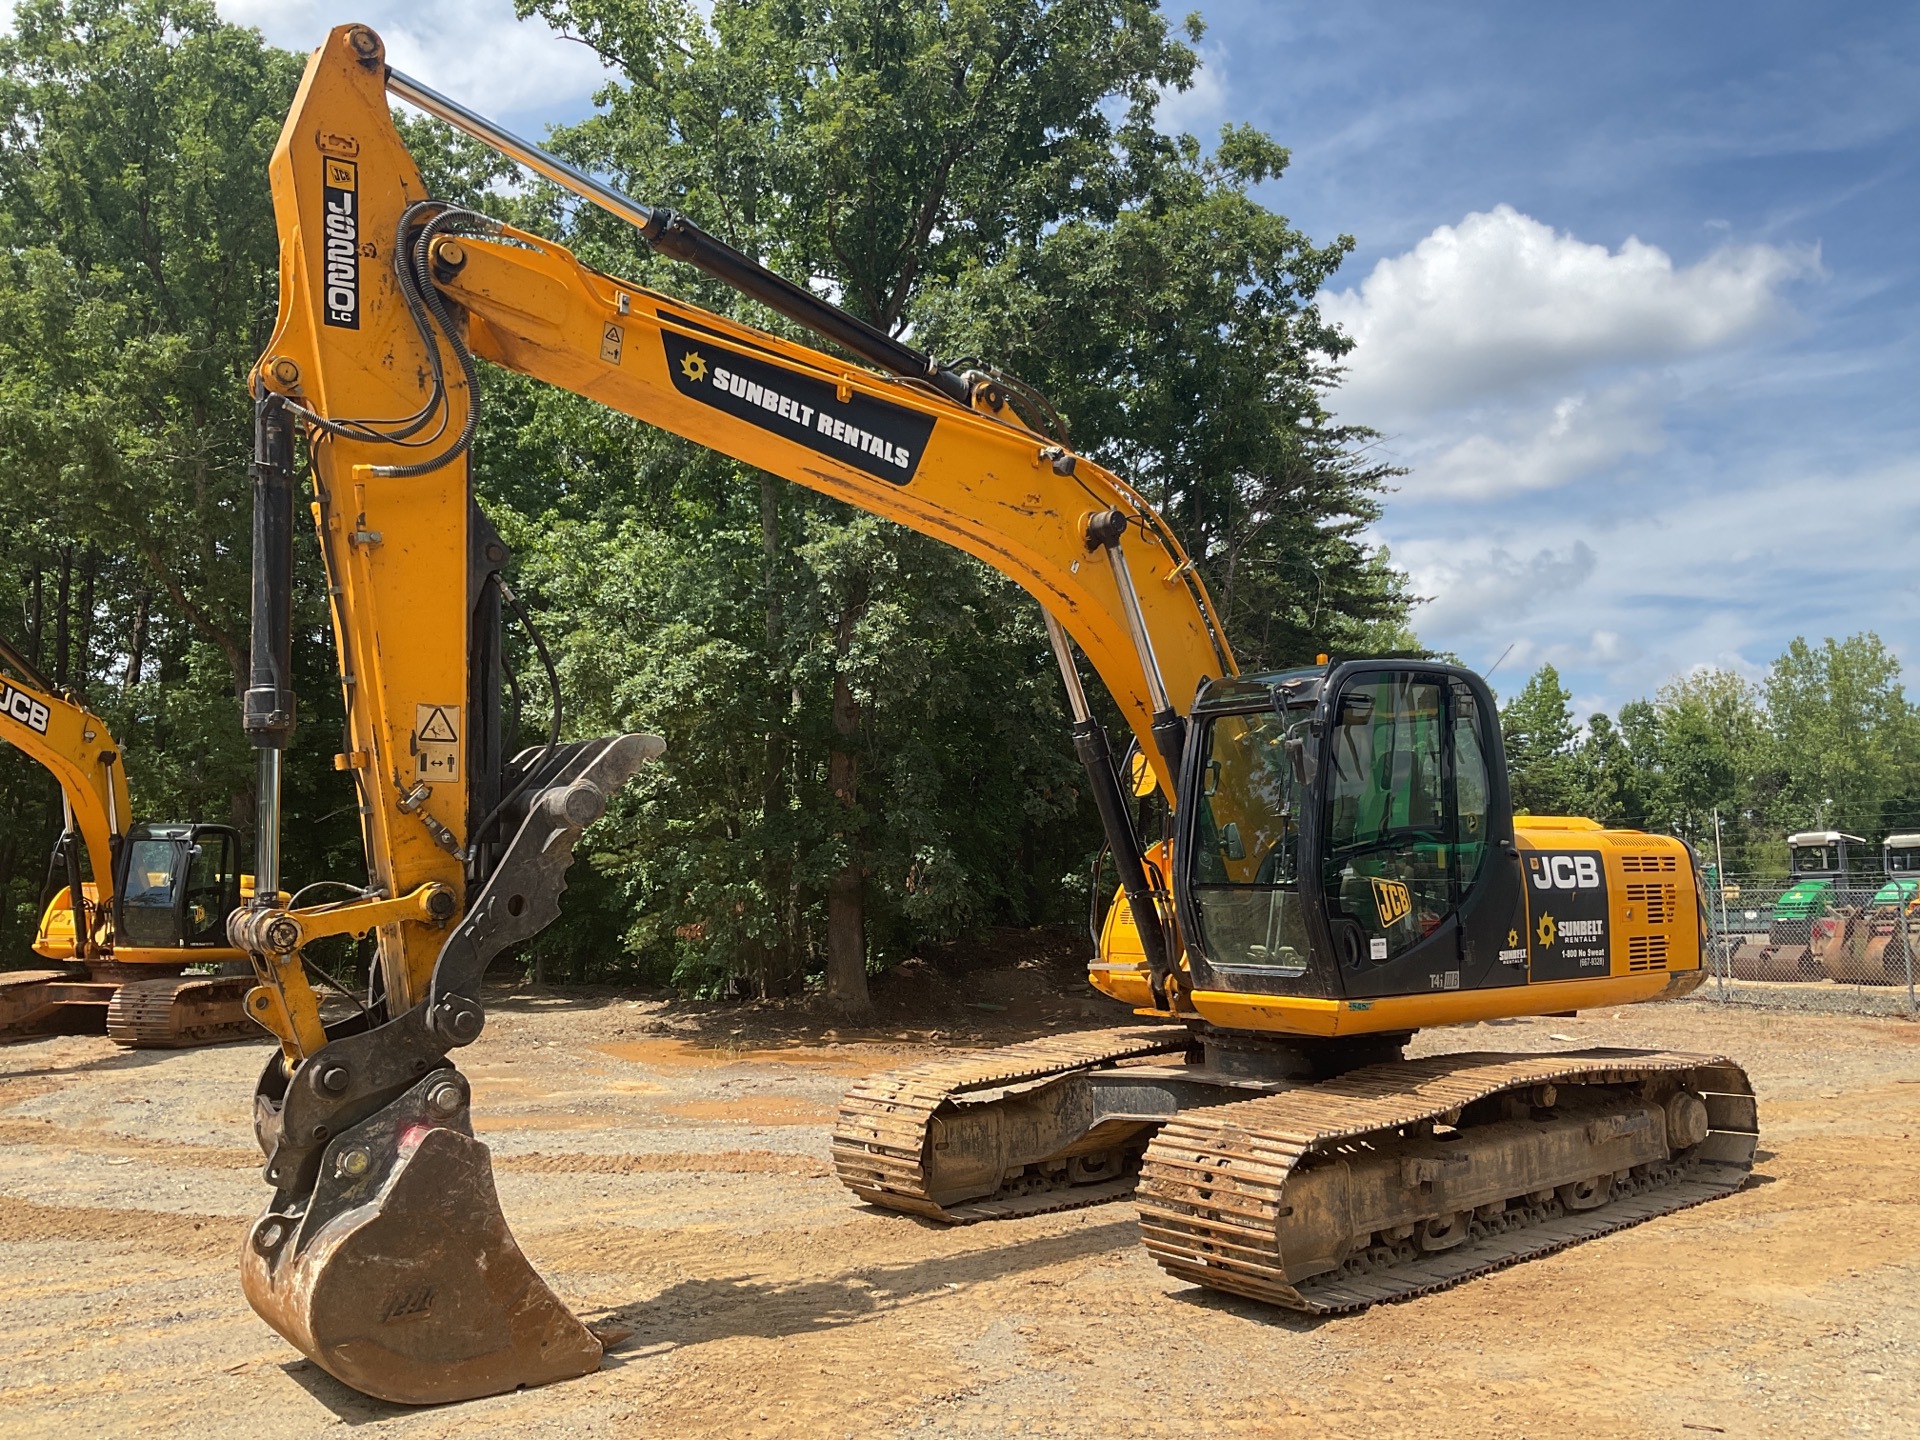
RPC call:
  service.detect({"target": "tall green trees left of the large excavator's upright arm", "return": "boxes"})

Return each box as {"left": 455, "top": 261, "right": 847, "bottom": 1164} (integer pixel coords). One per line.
{"left": 0, "top": 0, "right": 359, "bottom": 954}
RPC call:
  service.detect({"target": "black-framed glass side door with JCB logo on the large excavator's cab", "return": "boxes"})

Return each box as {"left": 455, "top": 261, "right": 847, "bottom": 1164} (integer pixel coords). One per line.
{"left": 1315, "top": 662, "right": 1526, "bottom": 996}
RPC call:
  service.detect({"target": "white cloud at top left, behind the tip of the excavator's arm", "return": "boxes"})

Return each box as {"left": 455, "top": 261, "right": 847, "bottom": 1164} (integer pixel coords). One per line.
{"left": 217, "top": 0, "right": 609, "bottom": 121}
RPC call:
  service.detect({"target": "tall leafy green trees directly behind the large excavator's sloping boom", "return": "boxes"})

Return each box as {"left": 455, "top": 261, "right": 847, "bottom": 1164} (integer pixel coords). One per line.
{"left": 486, "top": 0, "right": 1407, "bottom": 1008}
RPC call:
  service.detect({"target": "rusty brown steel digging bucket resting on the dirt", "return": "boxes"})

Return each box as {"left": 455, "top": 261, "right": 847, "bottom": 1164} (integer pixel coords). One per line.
{"left": 240, "top": 1068, "right": 601, "bottom": 1405}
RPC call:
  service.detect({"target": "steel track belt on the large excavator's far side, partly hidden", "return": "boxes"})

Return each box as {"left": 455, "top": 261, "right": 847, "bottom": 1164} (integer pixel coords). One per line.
{"left": 833, "top": 1025, "right": 1192, "bottom": 1225}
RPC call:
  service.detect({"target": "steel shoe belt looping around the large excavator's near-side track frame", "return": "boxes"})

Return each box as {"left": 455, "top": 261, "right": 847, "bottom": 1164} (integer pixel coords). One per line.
{"left": 1137, "top": 1050, "right": 1759, "bottom": 1313}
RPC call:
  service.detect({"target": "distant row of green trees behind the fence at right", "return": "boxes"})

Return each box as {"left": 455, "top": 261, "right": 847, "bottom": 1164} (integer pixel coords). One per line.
{"left": 1500, "top": 634, "right": 1920, "bottom": 874}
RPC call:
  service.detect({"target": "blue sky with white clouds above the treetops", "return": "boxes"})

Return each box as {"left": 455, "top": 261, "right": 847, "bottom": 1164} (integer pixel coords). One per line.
{"left": 221, "top": 0, "right": 1920, "bottom": 714}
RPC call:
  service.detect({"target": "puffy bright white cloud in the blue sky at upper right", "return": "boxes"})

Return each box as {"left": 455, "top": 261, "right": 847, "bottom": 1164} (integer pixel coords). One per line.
{"left": 1321, "top": 205, "right": 1818, "bottom": 424}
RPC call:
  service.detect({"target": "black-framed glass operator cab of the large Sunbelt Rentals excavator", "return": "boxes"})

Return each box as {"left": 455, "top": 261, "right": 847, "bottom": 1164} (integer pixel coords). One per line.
{"left": 1175, "top": 660, "right": 1526, "bottom": 998}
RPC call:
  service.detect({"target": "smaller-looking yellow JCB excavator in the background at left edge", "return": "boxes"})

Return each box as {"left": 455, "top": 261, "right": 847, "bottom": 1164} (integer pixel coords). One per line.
{"left": 0, "top": 639, "right": 259, "bottom": 1048}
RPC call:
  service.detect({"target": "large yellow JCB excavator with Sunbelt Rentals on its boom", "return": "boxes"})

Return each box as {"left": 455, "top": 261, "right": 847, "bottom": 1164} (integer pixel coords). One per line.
{"left": 230, "top": 25, "right": 1757, "bottom": 1404}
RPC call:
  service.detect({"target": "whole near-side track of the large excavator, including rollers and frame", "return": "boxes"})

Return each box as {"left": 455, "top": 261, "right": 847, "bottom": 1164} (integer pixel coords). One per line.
{"left": 1137, "top": 1050, "right": 1759, "bottom": 1313}
